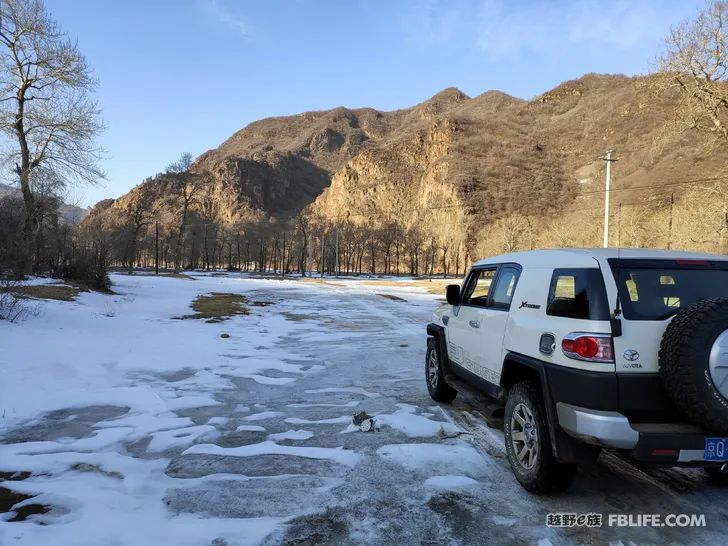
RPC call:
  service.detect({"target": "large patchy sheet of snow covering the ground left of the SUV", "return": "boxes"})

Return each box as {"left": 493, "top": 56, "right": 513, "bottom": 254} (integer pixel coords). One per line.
{"left": 0, "top": 274, "right": 452, "bottom": 546}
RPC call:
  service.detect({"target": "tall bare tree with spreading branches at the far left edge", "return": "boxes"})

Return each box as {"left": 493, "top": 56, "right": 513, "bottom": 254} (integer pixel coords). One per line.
{"left": 0, "top": 0, "right": 103, "bottom": 273}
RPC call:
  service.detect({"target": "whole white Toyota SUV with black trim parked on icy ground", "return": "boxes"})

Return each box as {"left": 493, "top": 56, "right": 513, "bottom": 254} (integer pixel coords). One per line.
{"left": 425, "top": 249, "right": 728, "bottom": 492}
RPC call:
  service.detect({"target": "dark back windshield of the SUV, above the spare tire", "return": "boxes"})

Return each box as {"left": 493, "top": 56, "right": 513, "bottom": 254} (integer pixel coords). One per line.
{"left": 609, "top": 260, "right": 728, "bottom": 320}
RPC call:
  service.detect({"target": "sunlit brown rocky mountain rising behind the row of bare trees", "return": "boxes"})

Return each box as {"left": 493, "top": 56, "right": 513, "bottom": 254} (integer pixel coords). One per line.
{"left": 91, "top": 71, "right": 726, "bottom": 244}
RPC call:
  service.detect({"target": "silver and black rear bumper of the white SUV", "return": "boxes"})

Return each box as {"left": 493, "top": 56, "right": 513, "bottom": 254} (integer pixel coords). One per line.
{"left": 556, "top": 402, "right": 724, "bottom": 466}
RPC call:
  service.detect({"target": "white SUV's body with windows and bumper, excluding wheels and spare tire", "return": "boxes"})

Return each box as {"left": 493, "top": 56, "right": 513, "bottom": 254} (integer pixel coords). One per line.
{"left": 427, "top": 245, "right": 728, "bottom": 472}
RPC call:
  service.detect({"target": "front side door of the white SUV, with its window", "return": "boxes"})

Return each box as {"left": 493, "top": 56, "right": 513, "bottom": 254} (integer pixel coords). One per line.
{"left": 447, "top": 266, "right": 498, "bottom": 378}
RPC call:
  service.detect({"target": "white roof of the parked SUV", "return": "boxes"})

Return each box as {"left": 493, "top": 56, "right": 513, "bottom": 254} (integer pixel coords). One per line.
{"left": 473, "top": 248, "right": 728, "bottom": 268}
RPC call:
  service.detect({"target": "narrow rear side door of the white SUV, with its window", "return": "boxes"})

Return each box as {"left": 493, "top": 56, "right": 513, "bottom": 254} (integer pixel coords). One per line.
{"left": 481, "top": 264, "right": 521, "bottom": 378}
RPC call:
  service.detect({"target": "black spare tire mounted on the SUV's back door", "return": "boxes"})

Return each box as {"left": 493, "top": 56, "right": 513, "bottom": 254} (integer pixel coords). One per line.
{"left": 659, "top": 298, "right": 728, "bottom": 434}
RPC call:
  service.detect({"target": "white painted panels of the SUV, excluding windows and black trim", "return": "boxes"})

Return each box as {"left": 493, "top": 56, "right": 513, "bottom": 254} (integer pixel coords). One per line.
{"left": 432, "top": 249, "right": 728, "bottom": 378}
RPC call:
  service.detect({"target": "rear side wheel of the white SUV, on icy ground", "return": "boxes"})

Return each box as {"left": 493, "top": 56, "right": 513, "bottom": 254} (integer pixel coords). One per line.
{"left": 503, "top": 381, "right": 577, "bottom": 493}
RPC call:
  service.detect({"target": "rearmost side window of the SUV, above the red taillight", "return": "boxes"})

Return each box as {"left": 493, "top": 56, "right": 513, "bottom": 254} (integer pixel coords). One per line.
{"left": 546, "top": 269, "right": 609, "bottom": 320}
